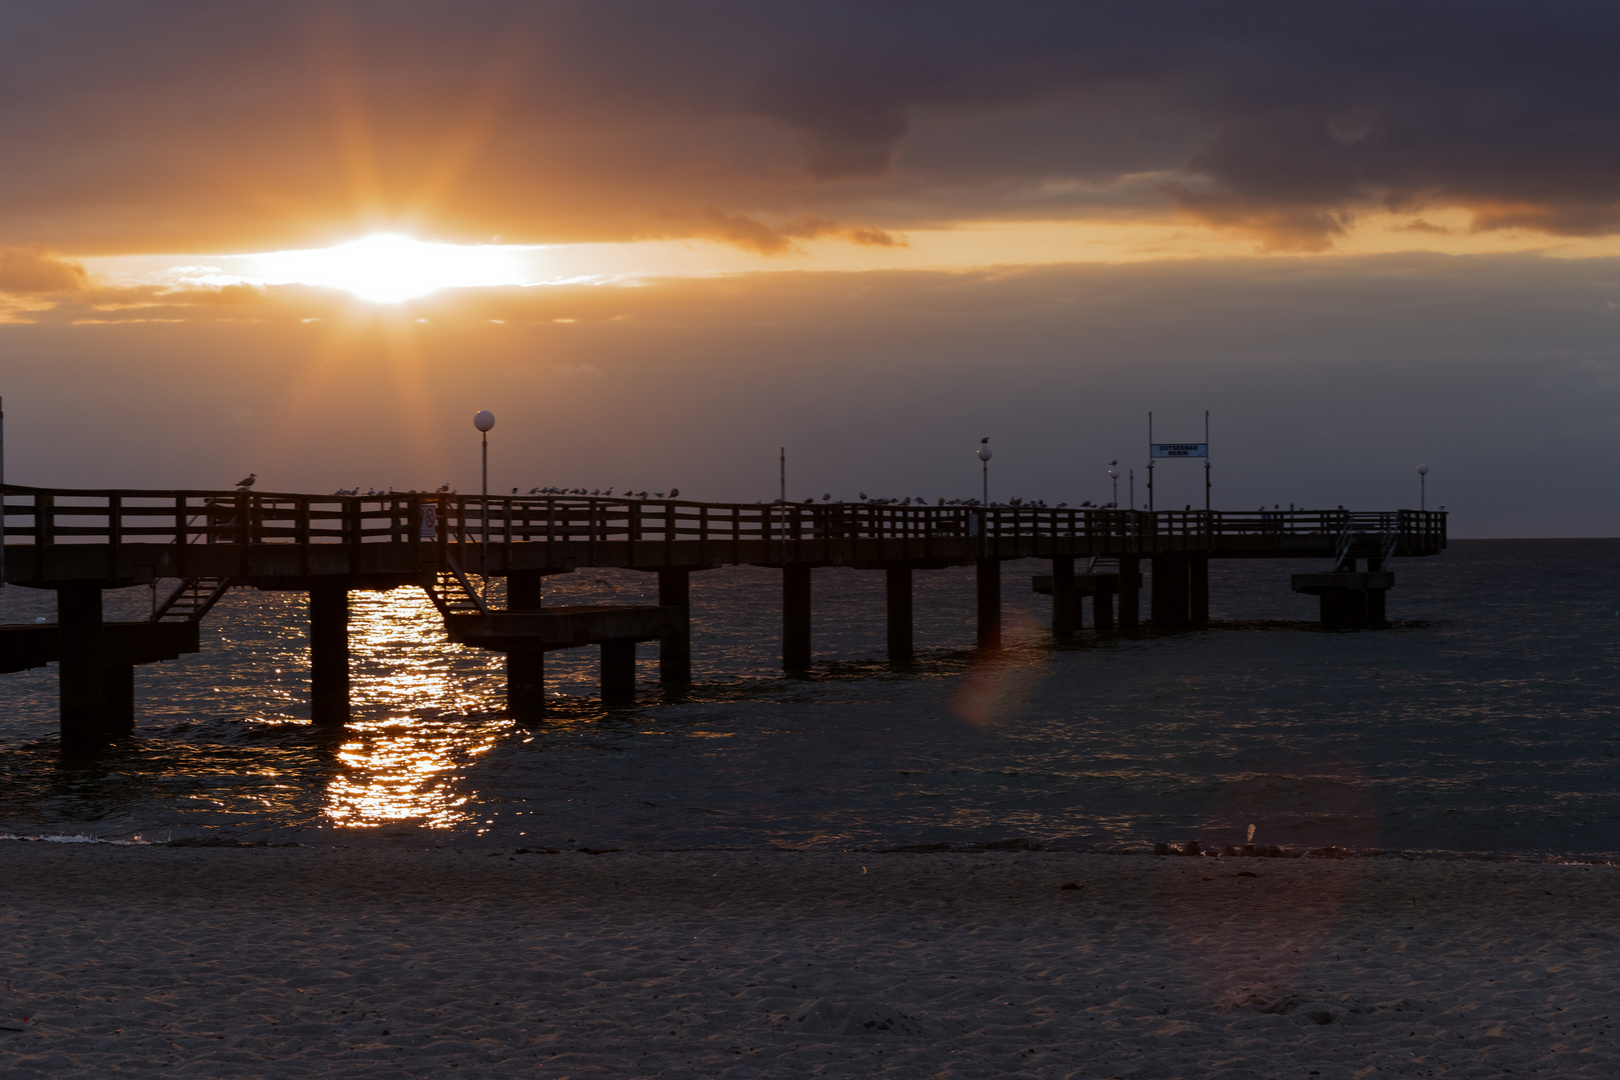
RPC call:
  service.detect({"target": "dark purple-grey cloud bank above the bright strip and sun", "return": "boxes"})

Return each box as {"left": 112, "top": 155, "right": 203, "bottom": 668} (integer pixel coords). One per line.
{"left": 0, "top": 0, "right": 1620, "bottom": 253}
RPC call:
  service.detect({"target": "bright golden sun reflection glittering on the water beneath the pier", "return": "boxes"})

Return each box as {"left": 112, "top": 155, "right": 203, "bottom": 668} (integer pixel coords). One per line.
{"left": 324, "top": 589, "right": 512, "bottom": 829}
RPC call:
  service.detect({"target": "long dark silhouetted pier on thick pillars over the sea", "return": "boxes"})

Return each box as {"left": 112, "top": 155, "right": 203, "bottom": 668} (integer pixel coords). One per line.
{"left": 0, "top": 486, "right": 1445, "bottom": 750}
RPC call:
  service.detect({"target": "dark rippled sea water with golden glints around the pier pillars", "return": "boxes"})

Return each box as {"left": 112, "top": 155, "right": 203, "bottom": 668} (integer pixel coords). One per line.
{"left": 0, "top": 541, "right": 1620, "bottom": 857}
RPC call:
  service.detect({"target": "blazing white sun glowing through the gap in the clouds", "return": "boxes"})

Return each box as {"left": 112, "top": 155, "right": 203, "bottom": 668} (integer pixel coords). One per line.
{"left": 249, "top": 233, "right": 531, "bottom": 304}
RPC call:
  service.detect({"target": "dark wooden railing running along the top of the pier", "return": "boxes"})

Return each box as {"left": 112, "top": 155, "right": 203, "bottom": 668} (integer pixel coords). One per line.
{"left": 5, "top": 486, "right": 1445, "bottom": 551}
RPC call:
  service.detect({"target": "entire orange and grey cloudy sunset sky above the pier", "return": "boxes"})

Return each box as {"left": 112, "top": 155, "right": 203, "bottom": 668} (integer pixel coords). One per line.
{"left": 0, "top": 0, "right": 1620, "bottom": 536}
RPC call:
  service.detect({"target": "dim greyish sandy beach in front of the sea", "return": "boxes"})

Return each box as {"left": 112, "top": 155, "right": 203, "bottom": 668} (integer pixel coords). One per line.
{"left": 0, "top": 842, "right": 1620, "bottom": 1078}
